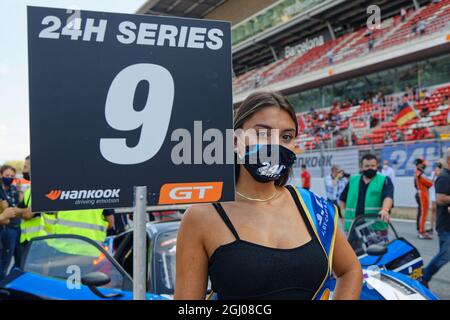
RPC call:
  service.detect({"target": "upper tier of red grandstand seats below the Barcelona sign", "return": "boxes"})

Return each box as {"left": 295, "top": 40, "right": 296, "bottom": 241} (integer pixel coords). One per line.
{"left": 233, "top": 0, "right": 450, "bottom": 94}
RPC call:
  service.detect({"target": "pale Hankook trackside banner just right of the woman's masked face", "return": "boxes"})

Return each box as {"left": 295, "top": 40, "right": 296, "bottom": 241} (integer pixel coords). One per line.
{"left": 292, "top": 149, "right": 359, "bottom": 184}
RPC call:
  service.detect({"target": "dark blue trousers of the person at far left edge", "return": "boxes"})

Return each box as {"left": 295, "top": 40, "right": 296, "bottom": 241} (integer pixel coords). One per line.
{"left": 0, "top": 226, "right": 22, "bottom": 280}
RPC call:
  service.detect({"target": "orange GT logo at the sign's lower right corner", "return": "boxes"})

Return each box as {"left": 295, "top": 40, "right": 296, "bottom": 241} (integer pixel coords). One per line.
{"left": 159, "top": 182, "right": 223, "bottom": 204}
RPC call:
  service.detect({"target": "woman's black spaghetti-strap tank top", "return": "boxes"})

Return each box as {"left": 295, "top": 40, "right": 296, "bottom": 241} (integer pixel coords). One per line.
{"left": 208, "top": 186, "right": 328, "bottom": 300}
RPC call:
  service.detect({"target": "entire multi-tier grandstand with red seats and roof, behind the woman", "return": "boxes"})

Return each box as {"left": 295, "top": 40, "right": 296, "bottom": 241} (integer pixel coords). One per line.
{"left": 139, "top": 0, "right": 450, "bottom": 150}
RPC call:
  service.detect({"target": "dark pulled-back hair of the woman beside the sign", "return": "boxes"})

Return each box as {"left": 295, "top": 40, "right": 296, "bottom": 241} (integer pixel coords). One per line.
{"left": 234, "top": 92, "right": 298, "bottom": 186}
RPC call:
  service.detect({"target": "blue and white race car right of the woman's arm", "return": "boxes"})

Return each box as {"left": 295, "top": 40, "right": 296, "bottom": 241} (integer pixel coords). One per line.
{"left": 334, "top": 215, "right": 438, "bottom": 300}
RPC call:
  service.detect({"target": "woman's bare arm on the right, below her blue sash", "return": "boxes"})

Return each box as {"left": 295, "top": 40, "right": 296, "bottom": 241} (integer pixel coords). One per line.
{"left": 333, "top": 229, "right": 363, "bottom": 300}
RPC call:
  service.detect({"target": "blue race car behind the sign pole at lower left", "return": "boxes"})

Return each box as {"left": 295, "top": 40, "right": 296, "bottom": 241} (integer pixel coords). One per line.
{"left": 0, "top": 221, "right": 179, "bottom": 300}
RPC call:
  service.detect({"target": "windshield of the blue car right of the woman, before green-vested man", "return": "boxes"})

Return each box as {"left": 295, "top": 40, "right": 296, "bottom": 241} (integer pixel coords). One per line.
{"left": 348, "top": 216, "right": 395, "bottom": 256}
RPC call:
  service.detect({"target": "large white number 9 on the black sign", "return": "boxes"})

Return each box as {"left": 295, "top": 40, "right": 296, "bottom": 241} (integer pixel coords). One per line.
{"left": 100, "top": 63, "right": 175, "bottom": 165}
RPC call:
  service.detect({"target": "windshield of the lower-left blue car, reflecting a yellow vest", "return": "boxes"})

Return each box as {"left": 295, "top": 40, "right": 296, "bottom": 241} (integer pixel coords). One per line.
{"left": 23, "top": 237, "right": 128, "bottom": 289}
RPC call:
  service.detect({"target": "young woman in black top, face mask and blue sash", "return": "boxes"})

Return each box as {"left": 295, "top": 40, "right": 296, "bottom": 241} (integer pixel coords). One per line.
{"left": 175, "top": 92, "right": 362, "bottom": 299}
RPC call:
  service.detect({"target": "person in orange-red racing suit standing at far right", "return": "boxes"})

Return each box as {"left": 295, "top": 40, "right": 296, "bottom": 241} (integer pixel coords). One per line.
{"left": 414, "top": 159, "right": 433, "bottom": 240}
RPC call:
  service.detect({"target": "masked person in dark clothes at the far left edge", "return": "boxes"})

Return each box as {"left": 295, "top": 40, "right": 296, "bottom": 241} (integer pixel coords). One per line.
{"left": 0, "top": 165, "right": 21, "bottom": 279}
